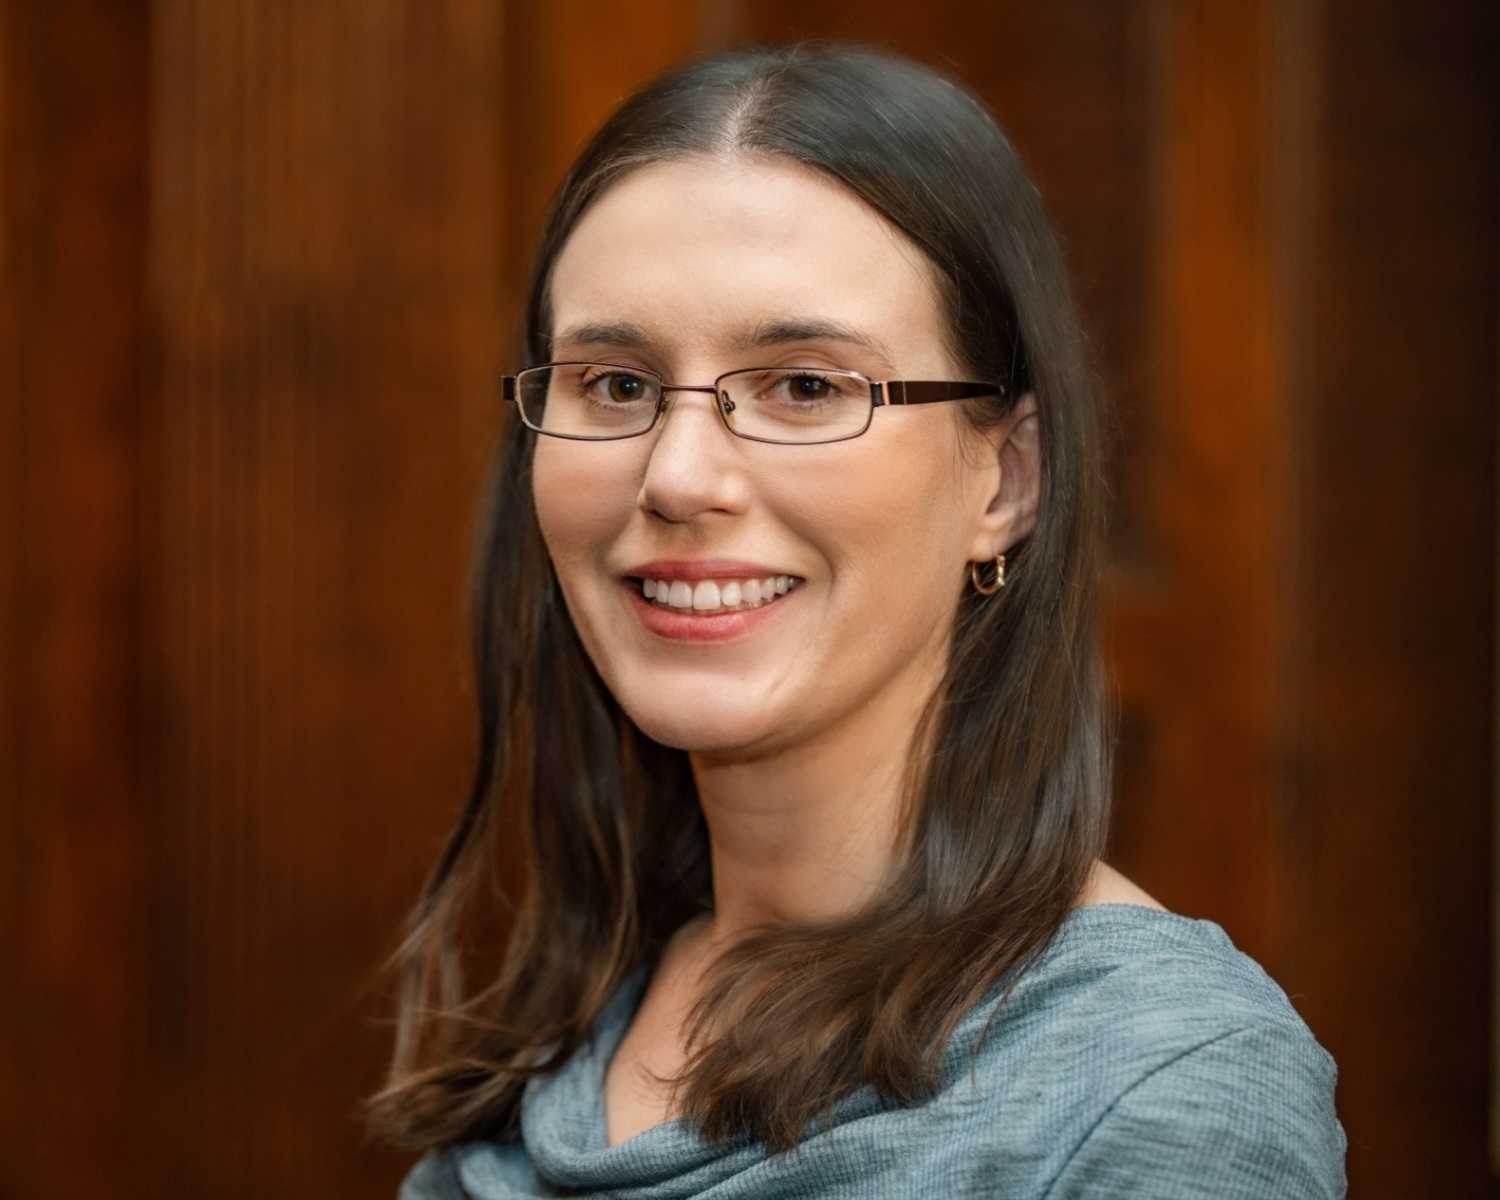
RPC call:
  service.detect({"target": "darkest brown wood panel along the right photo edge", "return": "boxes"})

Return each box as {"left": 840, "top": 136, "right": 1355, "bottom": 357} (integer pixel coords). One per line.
{"left": 1299, "top": 0, "right": 1500, "bottom": 1197}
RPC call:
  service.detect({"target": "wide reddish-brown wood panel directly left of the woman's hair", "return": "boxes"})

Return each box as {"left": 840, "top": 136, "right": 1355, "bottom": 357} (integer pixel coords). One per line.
{"left": 150, "top": 0, "right": 506, "bottom": 1197}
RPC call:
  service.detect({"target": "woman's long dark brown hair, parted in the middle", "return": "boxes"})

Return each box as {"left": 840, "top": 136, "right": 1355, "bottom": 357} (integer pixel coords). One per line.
{"left": 371, "top": 47, "right": 1107, "bottom": 1149}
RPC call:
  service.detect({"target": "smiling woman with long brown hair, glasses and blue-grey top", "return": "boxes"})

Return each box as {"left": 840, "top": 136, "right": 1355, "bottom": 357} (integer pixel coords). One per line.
{"left": 374, "top": 42, "right": 1344, "bottom": 1200}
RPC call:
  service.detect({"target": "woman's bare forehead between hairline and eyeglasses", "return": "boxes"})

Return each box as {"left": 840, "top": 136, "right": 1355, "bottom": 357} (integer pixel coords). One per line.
{"left": 549, "top": 158, "right": 947, "bottom": 365}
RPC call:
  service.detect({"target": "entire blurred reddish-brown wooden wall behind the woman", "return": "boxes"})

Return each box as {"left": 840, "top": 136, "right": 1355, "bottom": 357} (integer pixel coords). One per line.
{"left": 0, "top": 0, "right": 1500, "bottom": 1200}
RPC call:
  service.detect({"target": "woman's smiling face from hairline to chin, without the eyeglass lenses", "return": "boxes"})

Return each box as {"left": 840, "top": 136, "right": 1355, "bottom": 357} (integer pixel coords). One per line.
{"left": 534, "top": 158, "right": 1022, "bottom": 759}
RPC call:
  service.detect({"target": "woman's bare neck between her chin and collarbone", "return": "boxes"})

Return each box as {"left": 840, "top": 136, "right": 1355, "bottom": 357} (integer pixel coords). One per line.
{"left": 693, "top": 657, "right": 936, "bottom": 942}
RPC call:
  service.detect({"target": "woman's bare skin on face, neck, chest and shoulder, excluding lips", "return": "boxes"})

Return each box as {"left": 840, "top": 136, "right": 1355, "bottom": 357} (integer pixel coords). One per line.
{"left": 534, "top": 158, "right": 1161, "bottom": 1143}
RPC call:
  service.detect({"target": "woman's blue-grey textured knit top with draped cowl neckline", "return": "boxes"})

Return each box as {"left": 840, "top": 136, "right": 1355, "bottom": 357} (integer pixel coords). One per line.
{"left": 401, "top": 905, "right": 1344, "bottom": 1200}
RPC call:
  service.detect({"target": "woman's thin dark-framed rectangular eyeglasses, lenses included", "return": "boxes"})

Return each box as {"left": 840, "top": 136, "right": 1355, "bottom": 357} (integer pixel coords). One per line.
{"left": 501, "top": 363, "right": 1005, "bottom": 446}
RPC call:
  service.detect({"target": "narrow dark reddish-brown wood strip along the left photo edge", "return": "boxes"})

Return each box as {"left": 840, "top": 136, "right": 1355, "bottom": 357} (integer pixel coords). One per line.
{"left": 0, "top": 0, "right": 152, "bottom": 1197}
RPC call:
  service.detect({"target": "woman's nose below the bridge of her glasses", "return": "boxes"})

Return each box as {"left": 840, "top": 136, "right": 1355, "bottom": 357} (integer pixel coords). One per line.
{"left": 641, "top": 387, "right": 746, "bottom": 524}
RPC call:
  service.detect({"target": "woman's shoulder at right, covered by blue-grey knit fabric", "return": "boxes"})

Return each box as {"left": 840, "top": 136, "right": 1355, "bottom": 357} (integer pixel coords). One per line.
{"left": 951, "top": 903, "right": 1344, "bottom": 1200}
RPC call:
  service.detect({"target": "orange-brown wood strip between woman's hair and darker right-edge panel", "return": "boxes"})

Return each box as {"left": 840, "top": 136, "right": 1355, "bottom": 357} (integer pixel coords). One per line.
{"left": 1110, "top": 2, "right": 1307, "bottom": 978}
